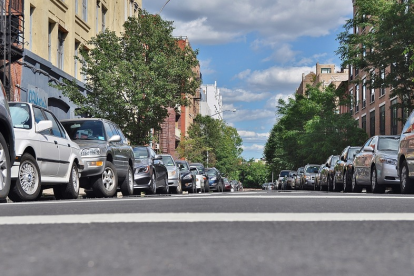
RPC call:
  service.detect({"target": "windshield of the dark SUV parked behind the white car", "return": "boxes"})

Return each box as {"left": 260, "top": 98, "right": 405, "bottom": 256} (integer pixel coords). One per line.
{"left": 62, "top": 120, "right": 105, "bottom": 141}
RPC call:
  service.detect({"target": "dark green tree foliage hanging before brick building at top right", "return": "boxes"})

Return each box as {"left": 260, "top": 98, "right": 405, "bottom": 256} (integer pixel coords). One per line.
{"left": 337, "top": 0, "right": 414, "bottom": 113}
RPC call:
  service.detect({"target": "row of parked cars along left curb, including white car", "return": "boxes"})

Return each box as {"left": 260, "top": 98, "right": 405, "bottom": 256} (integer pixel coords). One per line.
{"left": 0, "top": 92, "right": 238, "bottom": 201}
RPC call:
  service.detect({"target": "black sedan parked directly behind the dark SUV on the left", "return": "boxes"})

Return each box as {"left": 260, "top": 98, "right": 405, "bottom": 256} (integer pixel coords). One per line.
{"left": 132, "top": 146, "right": 170, "bottom": 194}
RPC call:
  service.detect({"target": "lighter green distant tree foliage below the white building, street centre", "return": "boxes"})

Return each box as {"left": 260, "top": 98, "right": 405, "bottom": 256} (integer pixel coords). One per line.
{"left": 178, "top": 115, "right": 242, "bottom": 179}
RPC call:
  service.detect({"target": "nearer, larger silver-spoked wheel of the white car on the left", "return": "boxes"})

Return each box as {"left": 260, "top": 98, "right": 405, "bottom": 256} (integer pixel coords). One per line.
{"left": 9, "top": 153, "right": 41, "bottom": 201}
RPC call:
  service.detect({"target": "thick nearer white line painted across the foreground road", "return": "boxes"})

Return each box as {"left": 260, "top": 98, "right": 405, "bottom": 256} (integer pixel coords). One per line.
{"left": 0, "top": 213, "right": 414, "bottom": 226}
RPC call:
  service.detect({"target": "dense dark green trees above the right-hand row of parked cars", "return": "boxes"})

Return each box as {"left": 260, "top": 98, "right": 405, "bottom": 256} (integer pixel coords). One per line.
{"left": 264, "top": 85, "right": 367, "bottom": 172}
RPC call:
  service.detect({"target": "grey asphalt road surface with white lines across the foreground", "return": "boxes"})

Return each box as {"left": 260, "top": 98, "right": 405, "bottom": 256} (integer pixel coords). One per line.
{"left": 0, "top": 191, "right": 414, "bottom": 276}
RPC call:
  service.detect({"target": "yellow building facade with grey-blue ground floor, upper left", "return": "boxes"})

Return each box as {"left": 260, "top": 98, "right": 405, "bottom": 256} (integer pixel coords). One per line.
{"left": 11, "top": 0, "right": 142, "bottom": 119}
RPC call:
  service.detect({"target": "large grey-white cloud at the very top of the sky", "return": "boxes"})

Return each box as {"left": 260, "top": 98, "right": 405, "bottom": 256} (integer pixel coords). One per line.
{"left": 142, "top": 0, "right": 352, "bottom": 45}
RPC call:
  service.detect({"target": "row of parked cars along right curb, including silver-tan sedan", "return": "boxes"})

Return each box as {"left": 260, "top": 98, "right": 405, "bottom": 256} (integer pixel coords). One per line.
{"left": 275, "top": 112, "right": 414, "bottom": 193}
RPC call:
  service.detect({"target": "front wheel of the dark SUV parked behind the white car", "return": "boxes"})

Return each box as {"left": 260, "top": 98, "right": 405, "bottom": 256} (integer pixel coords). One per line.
{"left": 92, "top": 161, "right": 118, "bottom": 197}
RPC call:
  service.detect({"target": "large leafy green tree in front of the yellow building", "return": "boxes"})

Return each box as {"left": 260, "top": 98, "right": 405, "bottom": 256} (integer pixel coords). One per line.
{"left": 52, "top": 10, "right": 200, "bottom": 144}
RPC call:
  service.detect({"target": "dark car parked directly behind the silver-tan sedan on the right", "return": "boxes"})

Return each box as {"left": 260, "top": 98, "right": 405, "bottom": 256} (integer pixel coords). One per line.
{"left": 332, "top": 146, "right": 361, "bottom": 192}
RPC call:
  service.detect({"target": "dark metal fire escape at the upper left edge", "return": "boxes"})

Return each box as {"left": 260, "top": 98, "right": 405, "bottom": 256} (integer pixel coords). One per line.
{"left": 0, "top": 0, "right": 24, "bottom": 100}
